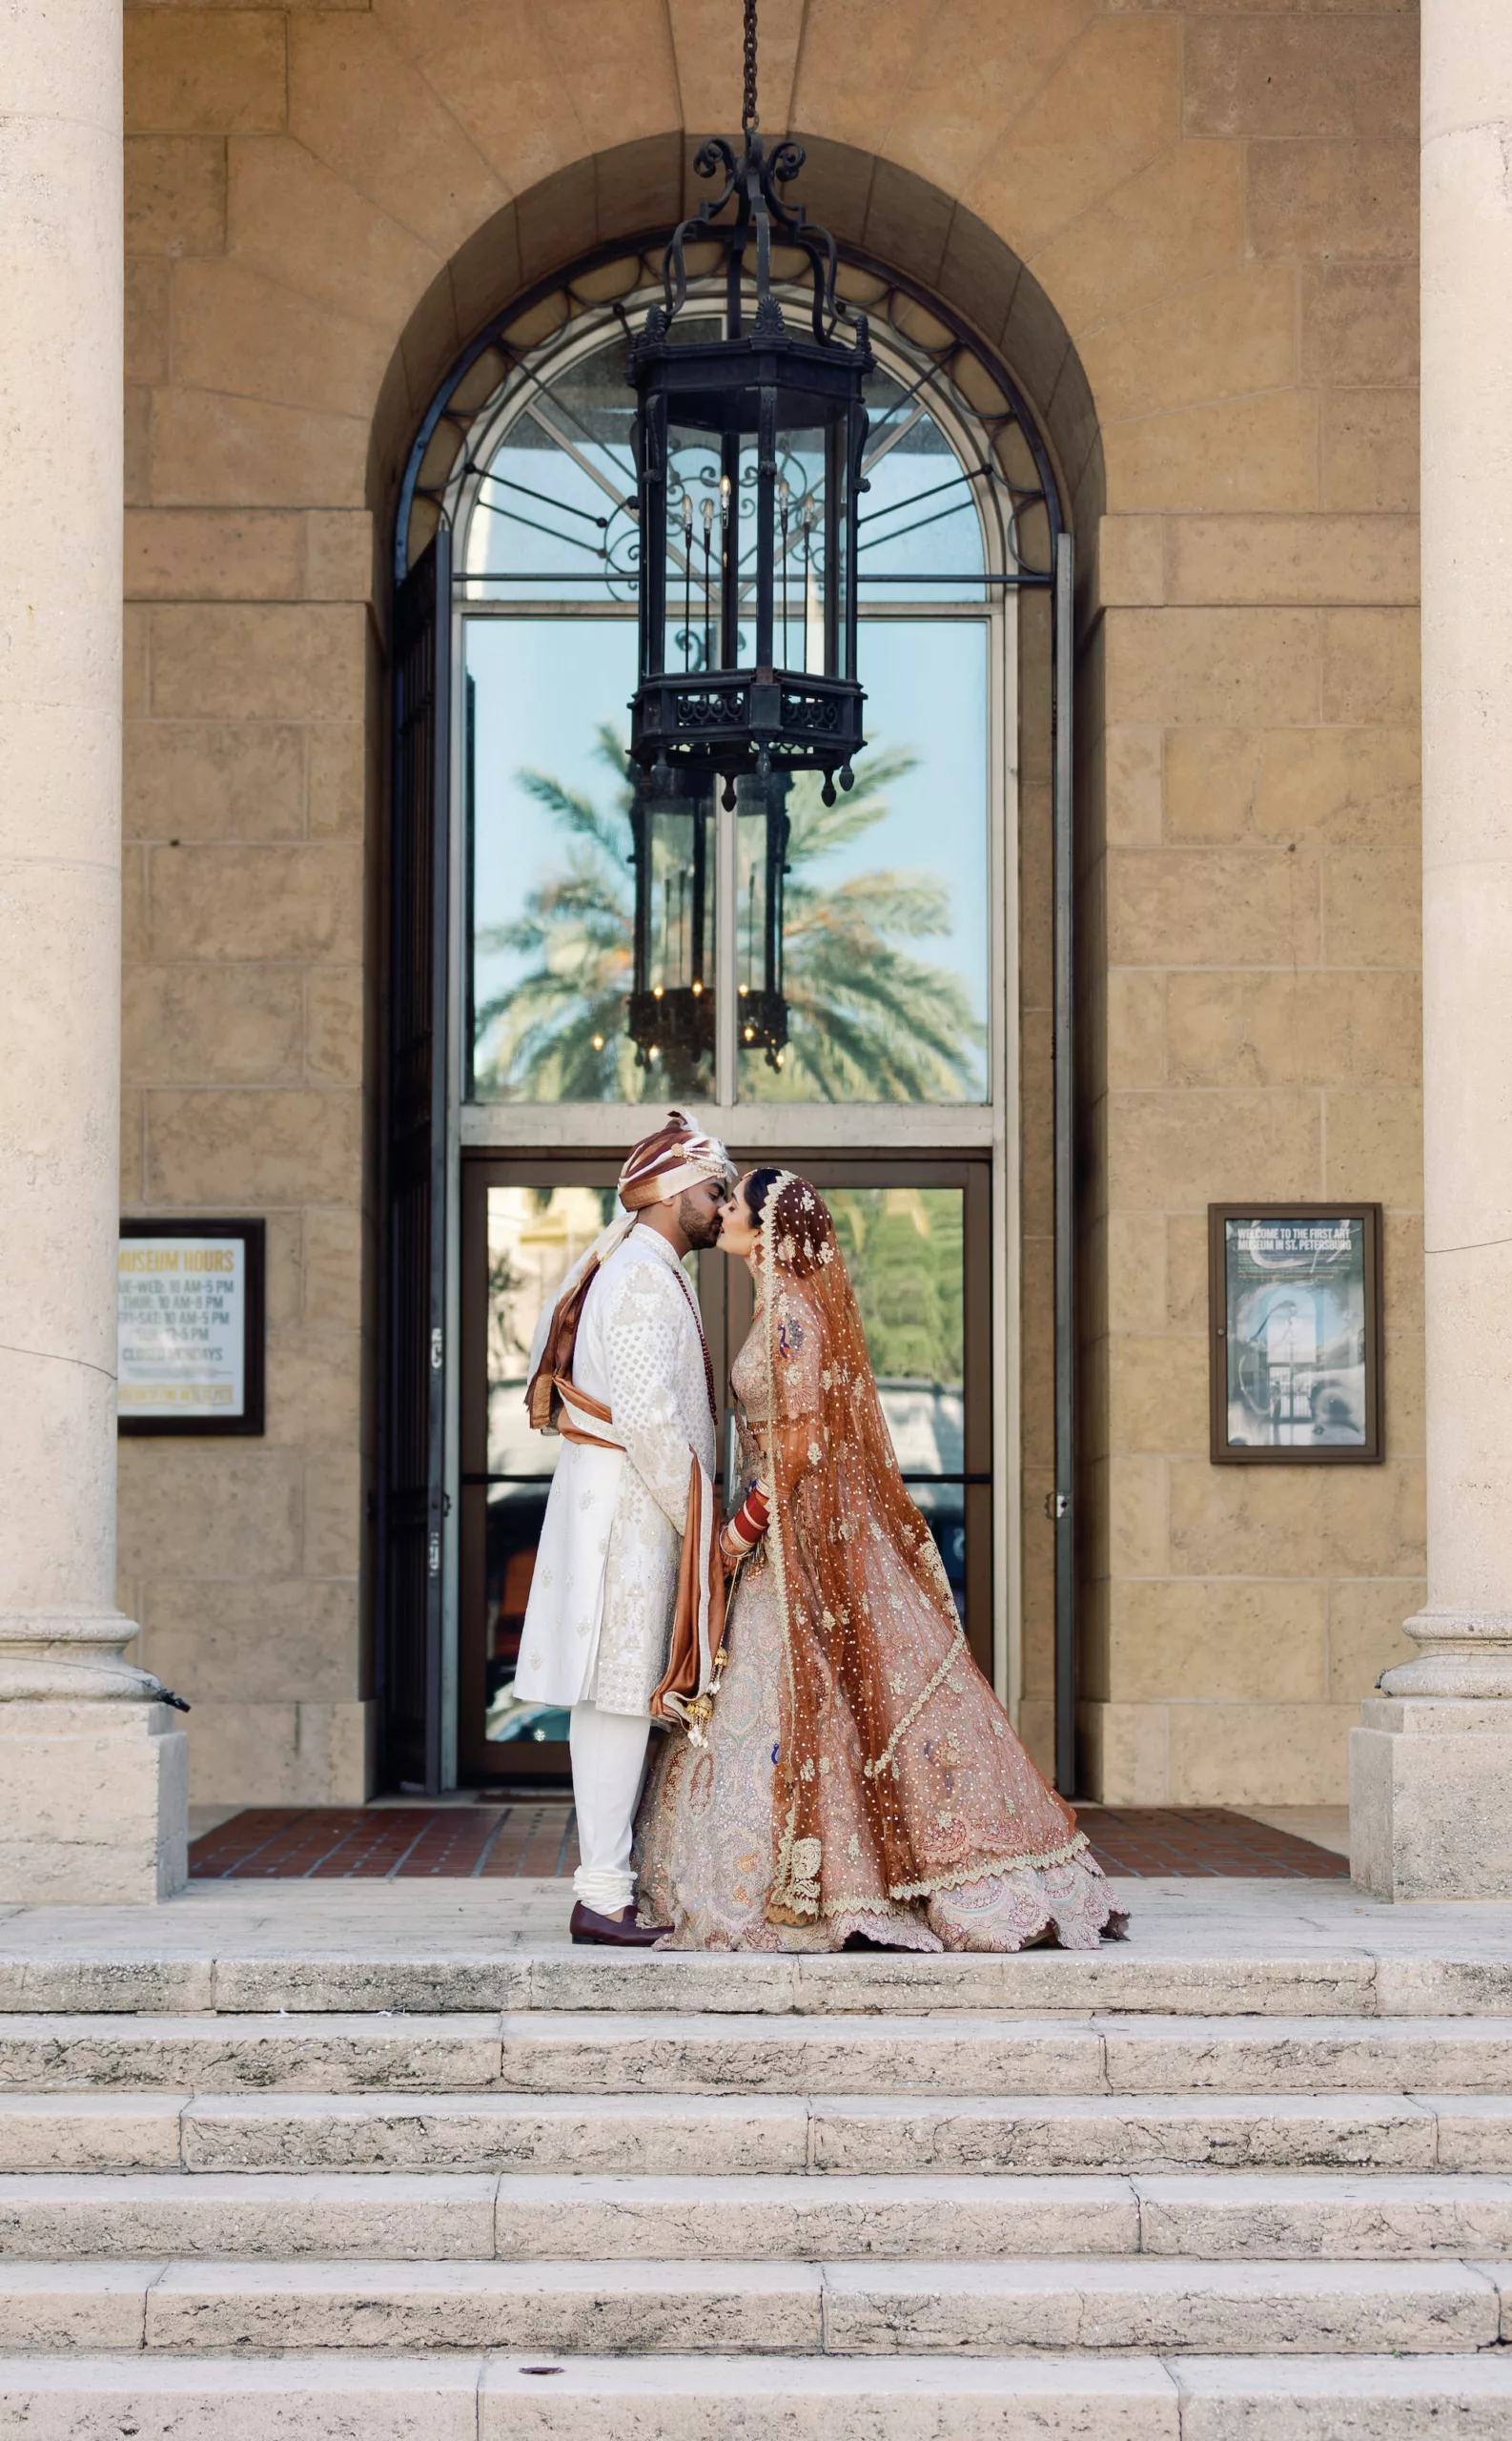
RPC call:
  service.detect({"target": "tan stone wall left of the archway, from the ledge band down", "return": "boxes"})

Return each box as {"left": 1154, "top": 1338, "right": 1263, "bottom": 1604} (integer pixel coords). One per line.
{"left": 119, "top": 507, "right": 371, "bottom": 1804}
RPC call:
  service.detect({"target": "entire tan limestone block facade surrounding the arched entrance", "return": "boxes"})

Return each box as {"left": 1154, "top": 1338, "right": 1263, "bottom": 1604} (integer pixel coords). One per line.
{"left": 119, "top": 0, "right": 1424, "bottom": 1804}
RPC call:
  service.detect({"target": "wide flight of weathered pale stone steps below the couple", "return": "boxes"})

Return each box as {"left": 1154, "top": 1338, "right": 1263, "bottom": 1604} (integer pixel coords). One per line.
{"left": 0, "top": 1945, "right": 1512, "bottom": 2441}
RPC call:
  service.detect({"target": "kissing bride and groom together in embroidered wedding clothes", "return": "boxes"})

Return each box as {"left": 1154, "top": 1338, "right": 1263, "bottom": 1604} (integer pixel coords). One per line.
{"left": 515, "top": 1111, "right": 1124, "bottom": 1950}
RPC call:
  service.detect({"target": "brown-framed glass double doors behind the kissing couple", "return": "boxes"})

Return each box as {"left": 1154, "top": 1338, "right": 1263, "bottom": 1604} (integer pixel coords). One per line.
{"left": 459, "top": 1155, "right": 992, "bottom": 1784}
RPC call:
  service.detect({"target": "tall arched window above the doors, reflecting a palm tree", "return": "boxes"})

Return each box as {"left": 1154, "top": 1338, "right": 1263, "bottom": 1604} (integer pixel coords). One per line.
{"left": 405, "top": 258, "right": 1052, "bottom": 1106}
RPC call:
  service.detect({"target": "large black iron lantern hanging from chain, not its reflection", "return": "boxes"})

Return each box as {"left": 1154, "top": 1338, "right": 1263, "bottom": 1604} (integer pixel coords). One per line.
{"left": 629, "top": 0, "right": 875, "bottom": 808}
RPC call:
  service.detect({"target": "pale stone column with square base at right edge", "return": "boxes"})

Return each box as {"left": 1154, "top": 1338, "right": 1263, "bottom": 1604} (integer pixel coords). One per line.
{"left": 1349, "top": 0, "right": 1512, "bottom": 1899}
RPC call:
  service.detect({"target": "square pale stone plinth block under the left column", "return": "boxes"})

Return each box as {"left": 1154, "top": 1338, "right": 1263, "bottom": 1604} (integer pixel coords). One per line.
{"left": 0, "top": 1701, "right": 188, "bottom": 1906}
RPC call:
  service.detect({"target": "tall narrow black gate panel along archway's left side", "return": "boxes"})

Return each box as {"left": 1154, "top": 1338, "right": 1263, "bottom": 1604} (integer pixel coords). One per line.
{"left": 378, "top": 527, "right": 451, "bottom": 1792}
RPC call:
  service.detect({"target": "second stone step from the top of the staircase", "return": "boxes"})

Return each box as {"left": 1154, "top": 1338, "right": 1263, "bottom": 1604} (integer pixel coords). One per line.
{"left": 0, "top": 2011, "right": 1512, "bottom": 2097}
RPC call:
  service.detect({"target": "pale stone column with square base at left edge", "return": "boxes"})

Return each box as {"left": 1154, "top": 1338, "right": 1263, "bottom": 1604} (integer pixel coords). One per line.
{"left": 0, "top": 0, "right": 188, "bottom": 1901}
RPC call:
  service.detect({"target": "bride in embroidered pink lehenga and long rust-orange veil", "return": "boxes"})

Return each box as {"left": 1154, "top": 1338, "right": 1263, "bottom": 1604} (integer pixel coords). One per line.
{"left": 637, "top": 1169, "right": 1124, "bottom": 1950}
